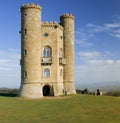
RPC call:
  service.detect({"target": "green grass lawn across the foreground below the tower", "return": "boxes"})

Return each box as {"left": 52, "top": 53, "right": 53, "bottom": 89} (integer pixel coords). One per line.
{"left": 0, "top": 95, "right": 120, "bottom": 123}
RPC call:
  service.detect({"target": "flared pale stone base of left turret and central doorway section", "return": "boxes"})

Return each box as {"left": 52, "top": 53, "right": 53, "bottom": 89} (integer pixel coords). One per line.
{"left": 19, "top": 82, "right": 64, "bottom": 98}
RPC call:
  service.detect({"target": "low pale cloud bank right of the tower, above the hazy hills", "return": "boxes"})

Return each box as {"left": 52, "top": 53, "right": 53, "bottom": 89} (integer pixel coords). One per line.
{"left": 75, "top": 51, "right": 120, "bottom": 84}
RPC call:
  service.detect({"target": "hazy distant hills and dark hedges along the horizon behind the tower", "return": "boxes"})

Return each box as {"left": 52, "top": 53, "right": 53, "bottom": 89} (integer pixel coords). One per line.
{"left": 0, "top": 82, "right": 120, "bottom": 97}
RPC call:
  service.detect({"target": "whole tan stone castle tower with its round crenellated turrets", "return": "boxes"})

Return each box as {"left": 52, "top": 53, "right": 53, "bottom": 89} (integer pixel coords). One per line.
{"left": 20, "top": 4, "right": 76, "bottom": 98}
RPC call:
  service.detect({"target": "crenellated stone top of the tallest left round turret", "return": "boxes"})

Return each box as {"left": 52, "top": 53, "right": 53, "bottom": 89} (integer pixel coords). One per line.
{"left": 20, "top": 3, "right": 42, "bottom": 11}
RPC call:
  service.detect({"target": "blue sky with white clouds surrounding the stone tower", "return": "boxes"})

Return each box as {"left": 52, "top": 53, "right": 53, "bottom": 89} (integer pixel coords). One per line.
{"left": 0, "top": 0, "right": 120, "bottom": 88}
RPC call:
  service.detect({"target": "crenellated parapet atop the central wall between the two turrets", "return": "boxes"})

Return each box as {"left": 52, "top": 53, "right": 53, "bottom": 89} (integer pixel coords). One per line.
{"left": 42, "top": 21, "right": 63, "bottom": 30}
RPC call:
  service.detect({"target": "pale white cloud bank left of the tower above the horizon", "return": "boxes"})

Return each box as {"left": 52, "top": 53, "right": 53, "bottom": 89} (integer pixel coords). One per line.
{"left": 0, "top": 49, "right": 20, "bottom": 87}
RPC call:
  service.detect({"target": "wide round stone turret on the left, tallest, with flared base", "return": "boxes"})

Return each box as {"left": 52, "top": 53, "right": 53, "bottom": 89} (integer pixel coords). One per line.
{"left": 20, "top": 4, "right": 42, "bottom": 98}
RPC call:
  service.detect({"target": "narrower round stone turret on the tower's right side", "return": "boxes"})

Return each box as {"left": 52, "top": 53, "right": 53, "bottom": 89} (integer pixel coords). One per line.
{"left": 60, "top": 14, "right": 76, "bottom": 94}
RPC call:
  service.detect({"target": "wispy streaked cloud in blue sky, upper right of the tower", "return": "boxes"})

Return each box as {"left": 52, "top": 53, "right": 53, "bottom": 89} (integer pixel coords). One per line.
{"left": 76, "top": 16, "right": 120, "bottom": 42}
